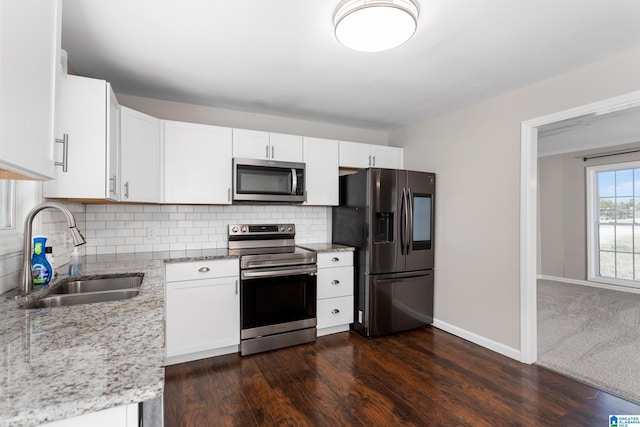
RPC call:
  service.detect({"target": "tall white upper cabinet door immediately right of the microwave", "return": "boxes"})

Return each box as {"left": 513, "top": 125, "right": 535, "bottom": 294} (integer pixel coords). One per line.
{"left": 303, "top": 137, "right": 339, "bottom": 206}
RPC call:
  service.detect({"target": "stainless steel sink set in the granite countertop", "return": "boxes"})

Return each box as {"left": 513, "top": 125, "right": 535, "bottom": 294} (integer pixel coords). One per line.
{"left": 24, "top": 273, "right": 144, "bottom": 308}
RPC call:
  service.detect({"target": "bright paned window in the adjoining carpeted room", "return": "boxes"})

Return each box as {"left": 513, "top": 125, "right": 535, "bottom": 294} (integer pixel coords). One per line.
{"left": 587, "top": 162, "right": 640, "bottom": 287}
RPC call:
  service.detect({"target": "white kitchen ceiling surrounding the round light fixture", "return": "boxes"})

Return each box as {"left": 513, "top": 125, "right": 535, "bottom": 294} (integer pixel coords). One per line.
{"left": 62, "top": 0, "right": 640, "bottom": 130}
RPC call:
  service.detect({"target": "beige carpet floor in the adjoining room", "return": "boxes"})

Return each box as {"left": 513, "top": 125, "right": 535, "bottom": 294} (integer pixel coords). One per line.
{"left": 537, "top": 280, "right": 640, "bottom": 403}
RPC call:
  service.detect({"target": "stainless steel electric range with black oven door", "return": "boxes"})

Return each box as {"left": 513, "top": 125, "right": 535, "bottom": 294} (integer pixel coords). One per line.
{"left": 229, "top": 224, "right": 318, "bottom": 355}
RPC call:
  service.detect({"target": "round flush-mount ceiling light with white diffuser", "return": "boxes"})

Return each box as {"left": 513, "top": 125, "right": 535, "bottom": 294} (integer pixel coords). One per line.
{"left": 333, "top": 0, "right": 418, "bottom": 52}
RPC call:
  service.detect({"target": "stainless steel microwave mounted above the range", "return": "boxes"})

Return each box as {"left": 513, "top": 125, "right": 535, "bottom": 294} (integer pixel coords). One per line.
{"left": 233, "top": 158, "right": 306, "bottom": 203}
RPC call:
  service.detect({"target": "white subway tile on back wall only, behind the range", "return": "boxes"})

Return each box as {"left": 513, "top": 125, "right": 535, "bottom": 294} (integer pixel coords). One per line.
{"left": 82, "top": 204, "right": 331, "bottom": 255}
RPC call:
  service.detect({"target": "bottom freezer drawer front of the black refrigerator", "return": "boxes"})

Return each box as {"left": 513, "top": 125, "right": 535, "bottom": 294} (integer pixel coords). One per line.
{"left": 368, "top": 271, "right": 433, "bottom": 337}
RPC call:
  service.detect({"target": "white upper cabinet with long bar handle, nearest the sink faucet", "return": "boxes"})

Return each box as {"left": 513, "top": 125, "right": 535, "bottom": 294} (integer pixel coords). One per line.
{"left": 43, "top": 75, "right": 120, "bottom": 200}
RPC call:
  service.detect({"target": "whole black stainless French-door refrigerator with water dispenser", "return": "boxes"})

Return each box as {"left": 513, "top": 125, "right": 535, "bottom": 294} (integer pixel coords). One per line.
{"left": 332, "top": 168, "right": 435, "bottom": 337}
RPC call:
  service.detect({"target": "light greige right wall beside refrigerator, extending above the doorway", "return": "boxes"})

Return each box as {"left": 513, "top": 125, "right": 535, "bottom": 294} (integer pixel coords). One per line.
{"left": 389, "top": 46, "right": 640, "bottom": 350}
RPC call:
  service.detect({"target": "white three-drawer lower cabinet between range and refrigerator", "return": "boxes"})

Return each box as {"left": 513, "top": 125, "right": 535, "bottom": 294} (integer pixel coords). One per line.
{"left": 317, "top": 251, "right": 353, "bottom": 336}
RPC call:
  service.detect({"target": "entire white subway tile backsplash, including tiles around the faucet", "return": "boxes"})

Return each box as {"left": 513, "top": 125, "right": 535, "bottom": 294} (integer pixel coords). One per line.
{"left": 0, "top": 201, "right": 331, "bottom": 294}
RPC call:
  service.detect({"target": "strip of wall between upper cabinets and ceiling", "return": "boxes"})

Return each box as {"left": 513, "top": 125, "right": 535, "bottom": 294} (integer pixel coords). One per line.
{"left": 116, "top": 94, "right": 388, "bottom": 145}
